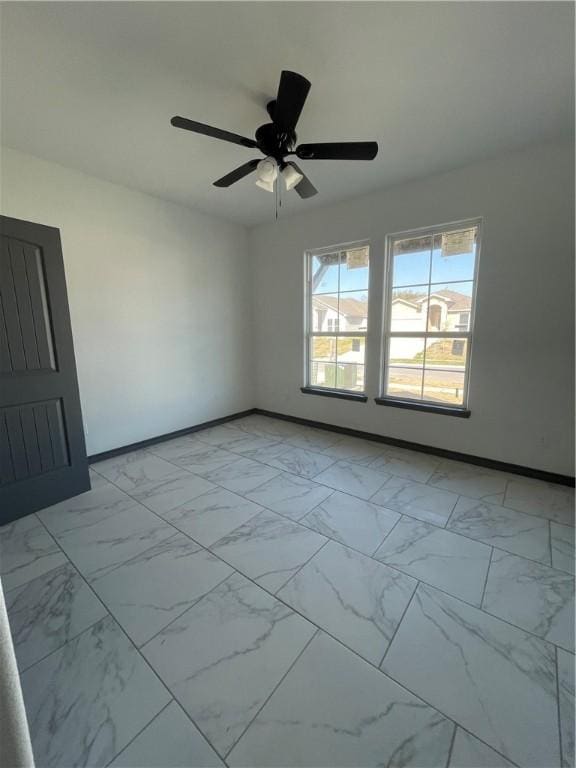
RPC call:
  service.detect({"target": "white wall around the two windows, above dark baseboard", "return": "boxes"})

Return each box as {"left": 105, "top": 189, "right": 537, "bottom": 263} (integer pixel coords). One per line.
{"left": 250, "top": 139, "right": 574, "bottom": 474}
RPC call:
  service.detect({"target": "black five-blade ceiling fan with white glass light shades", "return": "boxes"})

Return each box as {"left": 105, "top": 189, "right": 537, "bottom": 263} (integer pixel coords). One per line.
{"left": 170, "top": 70, "right": 378, "bottom": 198}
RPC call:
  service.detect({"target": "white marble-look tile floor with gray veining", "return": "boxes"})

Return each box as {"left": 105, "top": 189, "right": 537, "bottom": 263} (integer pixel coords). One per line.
{"left": 0, "top": 415, "right": 574, "bottom": 768}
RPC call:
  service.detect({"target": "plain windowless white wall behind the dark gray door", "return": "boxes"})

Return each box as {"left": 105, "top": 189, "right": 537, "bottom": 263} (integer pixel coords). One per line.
{"left": 1, "top": 149, "right": 255, "bottom": 454}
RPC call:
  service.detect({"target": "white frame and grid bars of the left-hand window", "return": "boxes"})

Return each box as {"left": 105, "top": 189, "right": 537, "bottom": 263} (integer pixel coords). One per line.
{"left": 301, "top": 239, "right": 372, "bottom": 402}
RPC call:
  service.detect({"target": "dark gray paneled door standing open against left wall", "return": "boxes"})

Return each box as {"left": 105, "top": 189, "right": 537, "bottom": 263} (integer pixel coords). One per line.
{"left": 0, "top": 216, "right": 90, "bottom": 525}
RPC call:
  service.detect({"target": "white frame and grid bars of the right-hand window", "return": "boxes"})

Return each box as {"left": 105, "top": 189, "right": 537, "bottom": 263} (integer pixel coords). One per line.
{"left": 376, "top": 216, "right": 483, "bottom": 416}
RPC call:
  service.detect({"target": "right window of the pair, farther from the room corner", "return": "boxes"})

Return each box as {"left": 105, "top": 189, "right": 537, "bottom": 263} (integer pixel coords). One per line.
{"left": 382, "top": 221, "right": 480, "bottom": 410}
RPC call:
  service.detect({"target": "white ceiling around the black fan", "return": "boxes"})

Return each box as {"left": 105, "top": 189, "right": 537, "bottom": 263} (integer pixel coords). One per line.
{"left": 1, "top": 2, "right": 574, "bottom": 225}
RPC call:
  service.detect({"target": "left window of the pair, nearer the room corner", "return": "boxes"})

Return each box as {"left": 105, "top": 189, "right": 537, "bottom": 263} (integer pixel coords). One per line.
{"left": 306, "top": 243, "right": 369, "bottom": 394}
